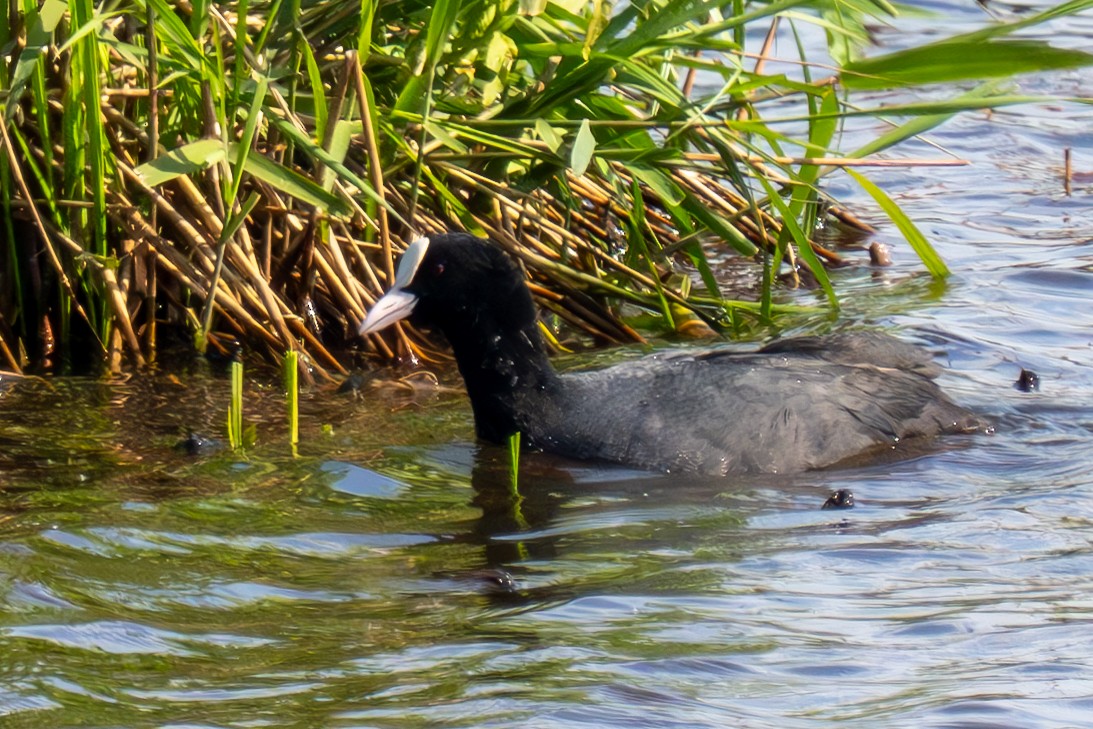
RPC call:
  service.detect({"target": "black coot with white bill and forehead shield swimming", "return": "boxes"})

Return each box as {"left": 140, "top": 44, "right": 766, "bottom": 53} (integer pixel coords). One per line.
{"left": 361, "top": 233, "right": 983, "bottom": 475}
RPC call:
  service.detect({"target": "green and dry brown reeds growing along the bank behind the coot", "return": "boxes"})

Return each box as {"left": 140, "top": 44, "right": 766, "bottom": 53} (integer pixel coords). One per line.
{"left": 0, "top": 0, "right": 1093, "bottom": 378}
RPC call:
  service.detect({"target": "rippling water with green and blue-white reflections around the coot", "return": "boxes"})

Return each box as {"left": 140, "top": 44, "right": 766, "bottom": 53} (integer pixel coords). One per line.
{"left": 0, "top": 3, "right": 1093, "bottom": 728}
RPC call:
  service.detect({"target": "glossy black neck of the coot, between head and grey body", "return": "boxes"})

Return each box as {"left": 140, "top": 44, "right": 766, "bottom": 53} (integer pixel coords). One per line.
{"left": 448, "top": 321, "right": 559, "bottom": 443}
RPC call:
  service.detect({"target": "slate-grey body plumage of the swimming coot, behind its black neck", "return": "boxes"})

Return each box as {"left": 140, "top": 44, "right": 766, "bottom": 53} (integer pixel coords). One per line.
{"left": 491, "top": 332, "right": 980, "bottom": 475}
